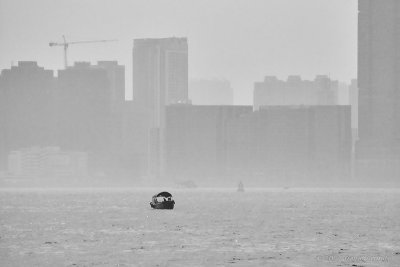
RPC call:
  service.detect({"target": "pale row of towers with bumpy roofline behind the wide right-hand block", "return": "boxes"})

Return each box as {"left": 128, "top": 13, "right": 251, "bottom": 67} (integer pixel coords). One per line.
{"left": 254, "top": 75, "right": 338, "bottom": 110}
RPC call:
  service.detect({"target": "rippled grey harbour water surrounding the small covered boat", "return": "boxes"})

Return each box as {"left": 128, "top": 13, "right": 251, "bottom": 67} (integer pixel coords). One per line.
{"left": 0, "top": 188, "right": 400, "bottom": 266}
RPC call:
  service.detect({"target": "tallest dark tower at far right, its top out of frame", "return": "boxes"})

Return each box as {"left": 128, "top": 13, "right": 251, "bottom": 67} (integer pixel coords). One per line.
{"left": 356, "top": 0, "right": 400, "bottom": 180}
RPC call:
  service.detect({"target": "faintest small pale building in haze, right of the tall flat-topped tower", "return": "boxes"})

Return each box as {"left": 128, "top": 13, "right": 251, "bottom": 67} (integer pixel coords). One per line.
{"left": 189, "top": 79, "right": 233, "bottom": 106}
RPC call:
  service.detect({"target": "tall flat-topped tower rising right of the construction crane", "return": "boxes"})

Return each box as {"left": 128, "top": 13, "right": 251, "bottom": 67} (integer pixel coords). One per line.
{"left": 132, "top": 37, "right": 188, "bottom": 127}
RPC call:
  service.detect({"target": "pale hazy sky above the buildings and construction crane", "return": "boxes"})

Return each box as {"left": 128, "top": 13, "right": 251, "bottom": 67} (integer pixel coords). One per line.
{"left": 0, "top": 0, "right": 357, "bottom": 104}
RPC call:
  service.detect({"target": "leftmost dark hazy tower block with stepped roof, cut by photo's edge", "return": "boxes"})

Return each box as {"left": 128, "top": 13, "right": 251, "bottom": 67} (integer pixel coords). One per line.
{"left": 0, "top": 61, "right": 56, "bottom": 171}
